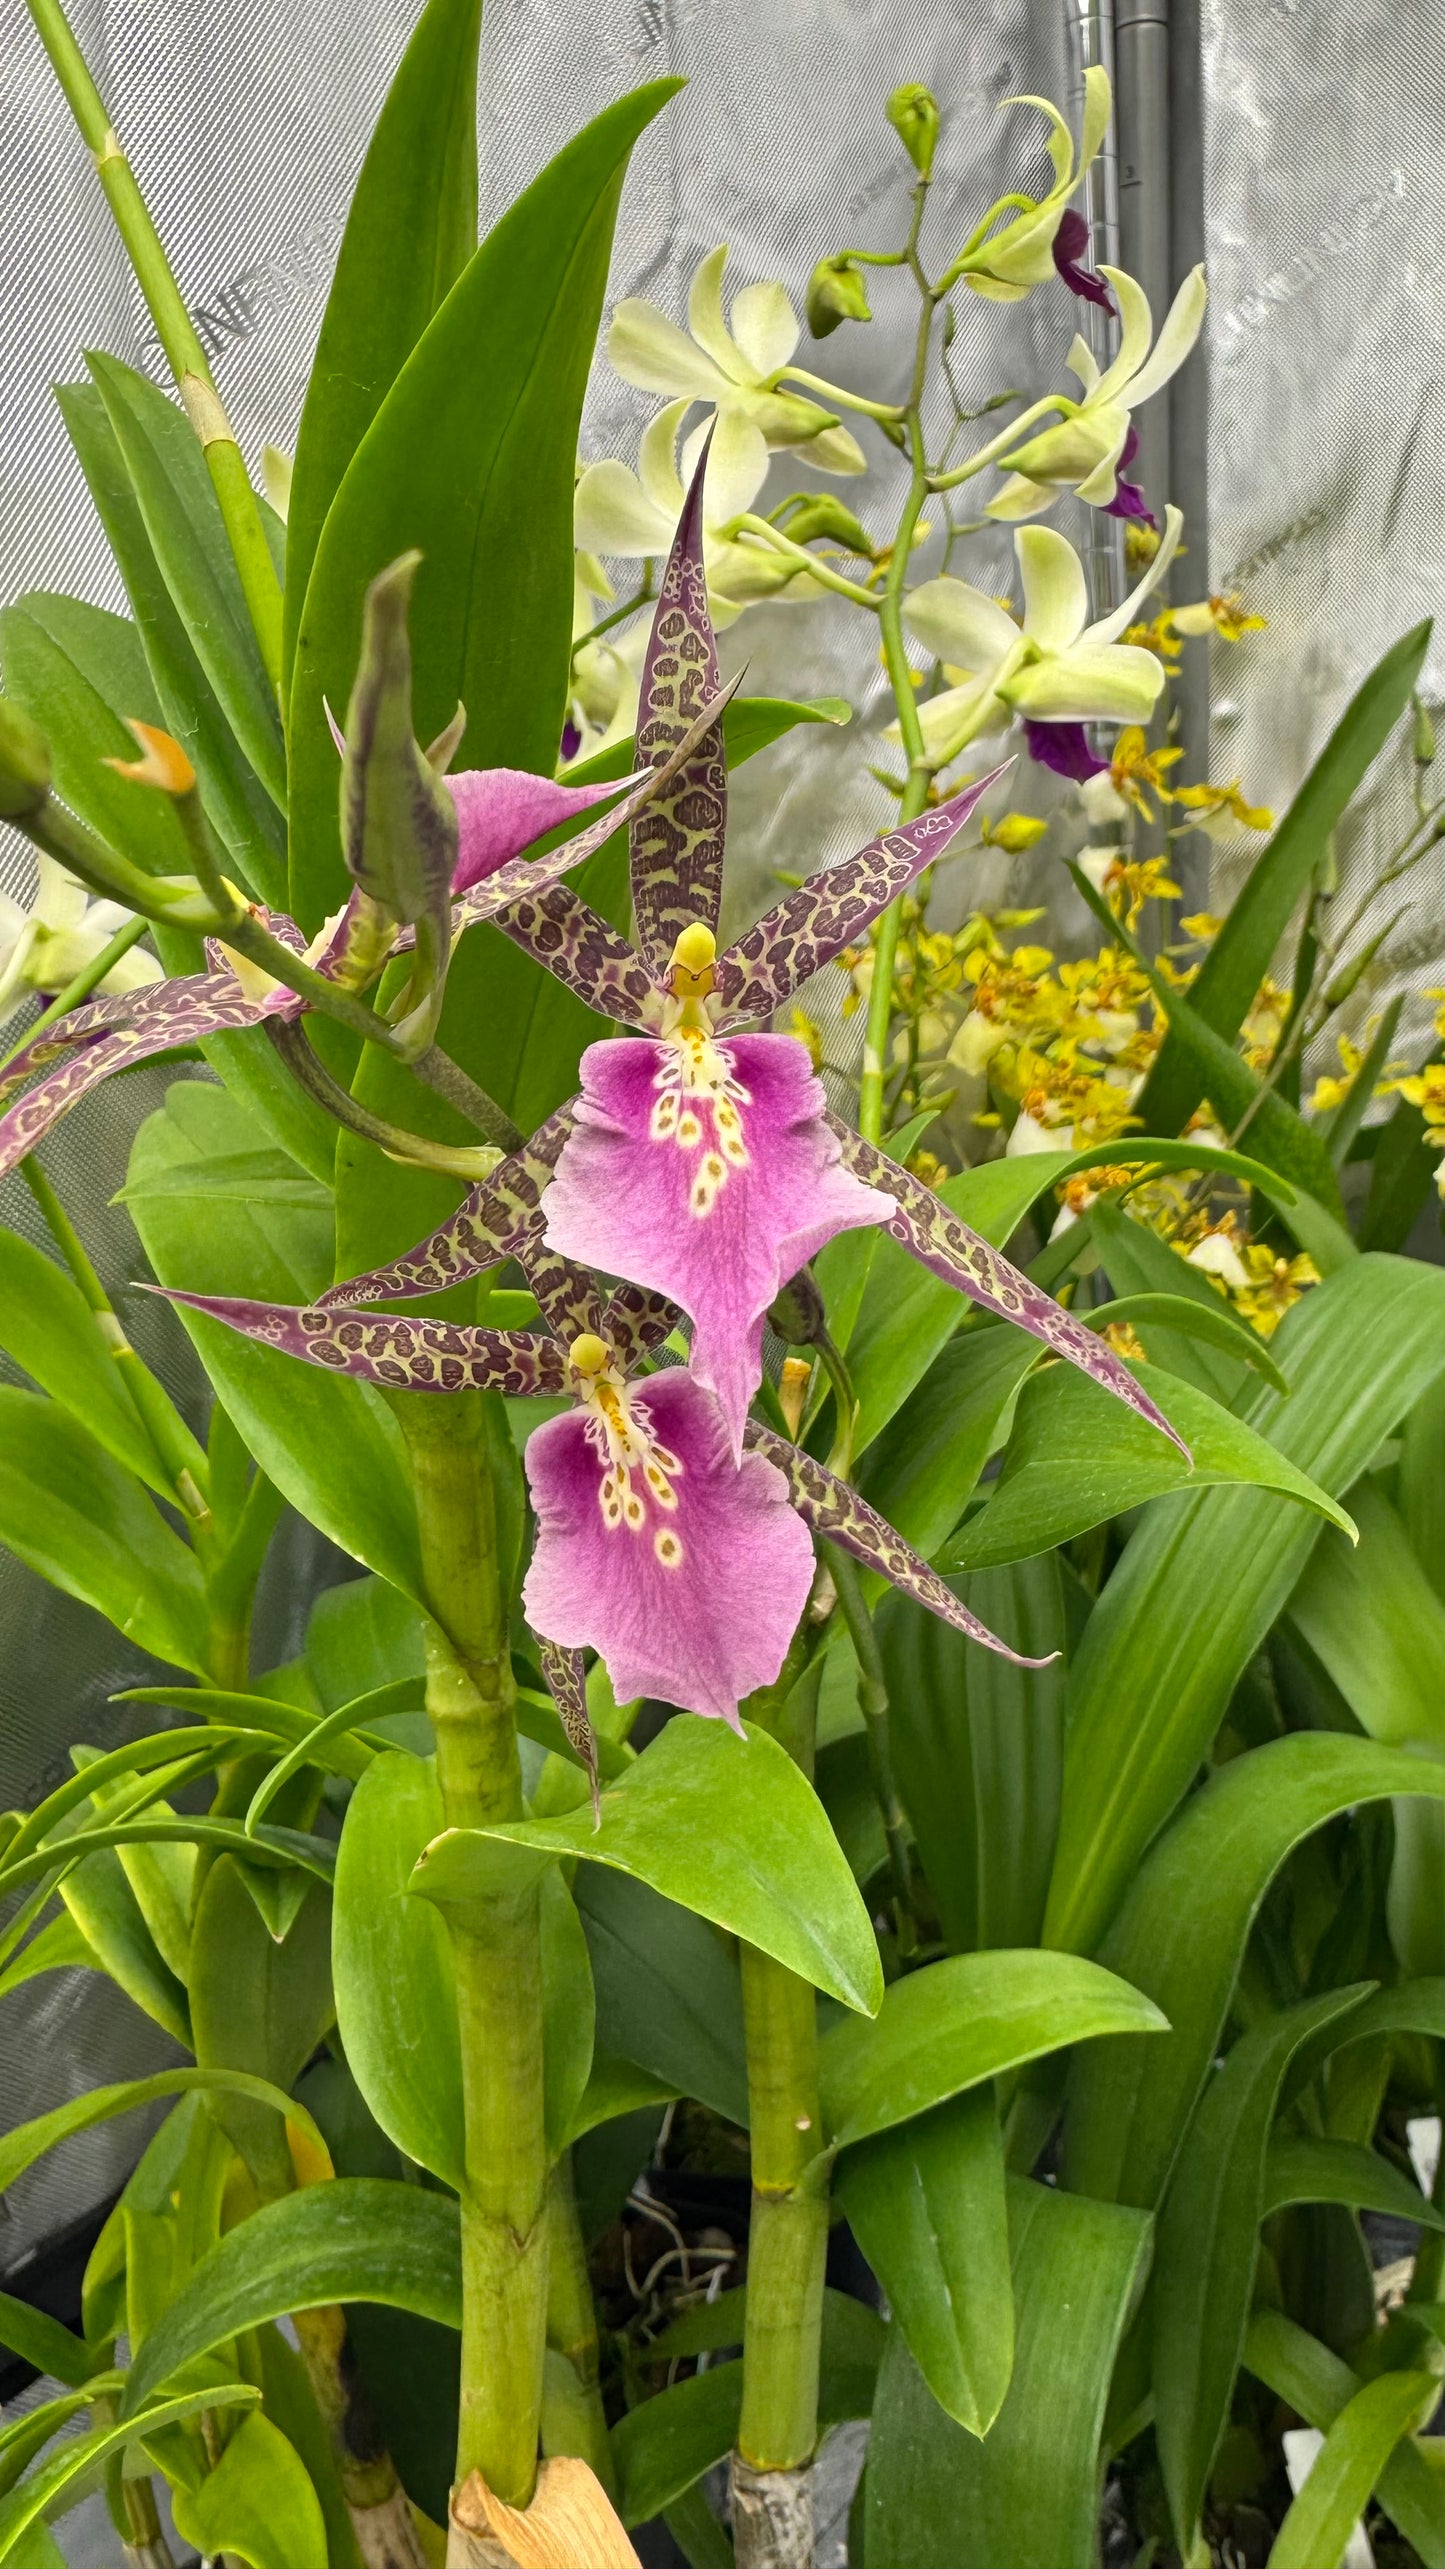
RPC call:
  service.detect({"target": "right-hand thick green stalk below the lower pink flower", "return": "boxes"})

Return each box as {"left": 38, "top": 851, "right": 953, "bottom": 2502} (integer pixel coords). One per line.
{"left": 738, "top": 1626, "right": 830, "bottom": 2471}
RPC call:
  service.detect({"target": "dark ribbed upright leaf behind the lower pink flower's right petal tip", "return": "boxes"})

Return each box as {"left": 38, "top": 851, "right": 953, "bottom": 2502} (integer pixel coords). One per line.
{"left": 877, "top": 1551, "right": 1067, "bottom": 1952}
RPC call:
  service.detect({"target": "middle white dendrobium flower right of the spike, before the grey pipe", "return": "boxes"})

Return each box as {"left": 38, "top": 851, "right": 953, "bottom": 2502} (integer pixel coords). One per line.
{"left": 987, "top": 267, "right": 1208, "bottom": 524}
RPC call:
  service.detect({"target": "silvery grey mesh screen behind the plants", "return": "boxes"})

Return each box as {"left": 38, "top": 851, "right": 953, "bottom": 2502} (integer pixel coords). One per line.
{"left": 0, "top": 0, "right": 1445, "bottom": 2271}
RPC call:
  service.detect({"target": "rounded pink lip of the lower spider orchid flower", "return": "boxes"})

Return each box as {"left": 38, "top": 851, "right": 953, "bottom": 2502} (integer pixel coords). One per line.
{"left": 522, "top": 1367, "right": 812, "bottom": 1726}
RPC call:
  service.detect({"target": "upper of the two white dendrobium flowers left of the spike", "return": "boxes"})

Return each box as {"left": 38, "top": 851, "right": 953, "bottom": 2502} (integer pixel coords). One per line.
{"left": 607, "top": 244, "right": 866, "bottom": 473}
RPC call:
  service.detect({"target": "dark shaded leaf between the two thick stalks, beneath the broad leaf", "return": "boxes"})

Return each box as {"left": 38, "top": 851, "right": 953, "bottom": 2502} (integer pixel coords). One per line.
{"left": 573, "top": 1865, "right": 748, "bottom": 2130}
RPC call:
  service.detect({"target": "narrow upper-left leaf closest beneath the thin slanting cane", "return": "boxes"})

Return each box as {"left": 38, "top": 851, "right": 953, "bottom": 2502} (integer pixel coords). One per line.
{"left": 85, "top": 349, "right": 285, "bottom": 812}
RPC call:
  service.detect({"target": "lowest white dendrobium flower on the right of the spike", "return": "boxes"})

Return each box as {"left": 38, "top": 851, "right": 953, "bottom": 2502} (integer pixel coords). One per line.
{"left": 902, "top": 509, "right": 1183, "bottom": 768}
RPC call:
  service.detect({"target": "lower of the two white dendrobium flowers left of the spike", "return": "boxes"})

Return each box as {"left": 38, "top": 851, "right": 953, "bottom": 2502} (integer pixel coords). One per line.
{"left": 573, "top": 401, "right": 818, "bottom": 624}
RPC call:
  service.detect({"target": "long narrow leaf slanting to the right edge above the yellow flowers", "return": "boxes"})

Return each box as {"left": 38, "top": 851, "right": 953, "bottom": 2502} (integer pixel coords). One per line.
{"left": 1139, "top": 622, "right": 1430, "bottom": 1148}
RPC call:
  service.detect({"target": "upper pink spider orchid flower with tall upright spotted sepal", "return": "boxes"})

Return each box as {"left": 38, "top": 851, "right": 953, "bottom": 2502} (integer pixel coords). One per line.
{"left": 323, "top": 465, "right": 1180, "bottom": 1454}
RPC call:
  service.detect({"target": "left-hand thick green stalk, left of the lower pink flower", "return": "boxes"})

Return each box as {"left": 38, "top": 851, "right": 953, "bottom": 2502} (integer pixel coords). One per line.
{"left": 393, "top": 1392, "right": 548, "bottom": 2507}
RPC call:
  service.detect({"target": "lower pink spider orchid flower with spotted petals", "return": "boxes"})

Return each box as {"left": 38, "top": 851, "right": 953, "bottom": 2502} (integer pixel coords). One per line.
{"left": 149, "top": 1112, "right": 1041, "bottom": 1765}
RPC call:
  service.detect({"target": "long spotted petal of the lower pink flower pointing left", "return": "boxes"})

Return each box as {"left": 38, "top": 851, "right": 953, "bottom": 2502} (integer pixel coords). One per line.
{"left": 147, "top": 1285, "right": 568, "bottom": 1400}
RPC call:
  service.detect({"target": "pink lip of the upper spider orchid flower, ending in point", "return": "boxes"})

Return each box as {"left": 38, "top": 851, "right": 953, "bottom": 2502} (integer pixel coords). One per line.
{"left": 543, "top": 1025, "right": 887, "bottom": 1451}
